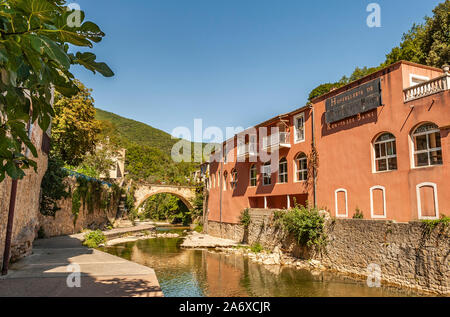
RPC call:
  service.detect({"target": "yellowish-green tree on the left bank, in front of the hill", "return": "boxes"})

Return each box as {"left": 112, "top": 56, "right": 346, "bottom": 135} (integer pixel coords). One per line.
{"left": 51, "top": 80, "right": 100, "bottom": 166}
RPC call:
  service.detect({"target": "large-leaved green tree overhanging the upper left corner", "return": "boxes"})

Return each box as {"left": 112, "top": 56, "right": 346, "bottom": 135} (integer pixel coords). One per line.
{"left": 0, "top": 0, "right": 114, "bottom": 182}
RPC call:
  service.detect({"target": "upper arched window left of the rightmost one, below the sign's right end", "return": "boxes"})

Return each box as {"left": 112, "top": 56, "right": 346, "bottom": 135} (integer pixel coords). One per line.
{"left": 373, "top": 133, "right": 397, "bottom": 172}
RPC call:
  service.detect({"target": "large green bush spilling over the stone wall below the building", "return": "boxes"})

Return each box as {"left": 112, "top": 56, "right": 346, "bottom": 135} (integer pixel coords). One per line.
{"left": 279, "top": 206, "right": 327, "bottom": 248}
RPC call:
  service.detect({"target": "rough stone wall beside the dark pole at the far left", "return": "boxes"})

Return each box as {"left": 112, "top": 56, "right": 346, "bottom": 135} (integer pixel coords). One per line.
{"left": 0, "top": 128, "right": 47, "bottom": 267}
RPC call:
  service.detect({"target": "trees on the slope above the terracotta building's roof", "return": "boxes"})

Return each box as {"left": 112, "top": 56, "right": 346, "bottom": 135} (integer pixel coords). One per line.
{"left": 308, "top": 0, "right": 450, "bottom": 101}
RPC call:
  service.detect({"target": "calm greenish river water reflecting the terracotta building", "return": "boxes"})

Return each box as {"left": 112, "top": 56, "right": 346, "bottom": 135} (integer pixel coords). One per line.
{"left": 102, "top": 228, "right": 423, "bottom": 297}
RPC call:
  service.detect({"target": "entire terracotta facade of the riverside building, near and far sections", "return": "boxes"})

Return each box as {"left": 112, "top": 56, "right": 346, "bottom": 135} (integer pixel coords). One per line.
{"left": 208, "top": 63, "right": 450, "bottom": 223}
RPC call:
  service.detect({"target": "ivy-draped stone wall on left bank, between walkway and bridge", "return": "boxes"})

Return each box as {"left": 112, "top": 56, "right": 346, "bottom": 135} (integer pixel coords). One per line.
{"left": 39, "top": 178, "right": 119, "bottom": 237}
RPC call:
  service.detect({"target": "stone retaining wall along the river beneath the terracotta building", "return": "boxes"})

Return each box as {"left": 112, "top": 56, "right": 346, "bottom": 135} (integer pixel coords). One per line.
{"left": 208, "top": 210, "right": 450, "bottom": 295}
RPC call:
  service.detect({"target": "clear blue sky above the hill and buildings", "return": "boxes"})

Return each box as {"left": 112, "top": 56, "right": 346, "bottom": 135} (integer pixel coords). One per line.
{"left": 69, "top": 0, "right": 441, "bottom": 138}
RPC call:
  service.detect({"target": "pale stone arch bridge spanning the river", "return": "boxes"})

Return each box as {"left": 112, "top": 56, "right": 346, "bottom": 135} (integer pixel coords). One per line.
{"left": 134, "top": 183, "right": 196, "bottom": 210}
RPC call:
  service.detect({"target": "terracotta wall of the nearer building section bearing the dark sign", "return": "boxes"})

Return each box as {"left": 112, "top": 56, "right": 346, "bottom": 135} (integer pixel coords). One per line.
{"left": 315, "top": 64, "right": 450, "bottom": 221}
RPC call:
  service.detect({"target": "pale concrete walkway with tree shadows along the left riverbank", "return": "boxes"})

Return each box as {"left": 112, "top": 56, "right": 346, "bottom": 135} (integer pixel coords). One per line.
{"left": 0, "top": 236, "right": 163, "bottom": 297}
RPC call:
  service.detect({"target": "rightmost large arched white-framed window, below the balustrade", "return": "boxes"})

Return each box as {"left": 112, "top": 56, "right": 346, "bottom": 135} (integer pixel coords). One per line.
{"left": 412, "top": 123, "right": 442, "bottom": 167}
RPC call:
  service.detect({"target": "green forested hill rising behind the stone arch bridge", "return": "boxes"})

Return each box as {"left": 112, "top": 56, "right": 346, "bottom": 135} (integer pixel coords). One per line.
{"left": 96, "top": 108, "right": 198, "bottom": 184}
